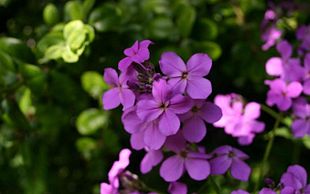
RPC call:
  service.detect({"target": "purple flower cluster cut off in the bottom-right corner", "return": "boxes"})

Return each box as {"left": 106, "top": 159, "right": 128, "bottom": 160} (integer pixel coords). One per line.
{"left": 231, "top": 165, "right": 310, "bottom": 194}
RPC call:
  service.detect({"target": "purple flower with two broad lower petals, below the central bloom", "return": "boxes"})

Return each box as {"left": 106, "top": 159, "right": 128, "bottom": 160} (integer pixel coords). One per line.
{"left": 160, "top": 134, "right": 210, "bottom": 182}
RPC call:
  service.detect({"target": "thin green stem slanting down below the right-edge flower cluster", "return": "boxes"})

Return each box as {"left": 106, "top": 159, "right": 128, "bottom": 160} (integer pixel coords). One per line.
{"left": 255, "top": 112, "right": 282, "bottom": 191}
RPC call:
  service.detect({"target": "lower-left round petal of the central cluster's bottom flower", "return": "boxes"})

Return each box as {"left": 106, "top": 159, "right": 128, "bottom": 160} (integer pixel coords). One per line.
{"left": 159, "top": 155, "right": 184, "bottom": 182}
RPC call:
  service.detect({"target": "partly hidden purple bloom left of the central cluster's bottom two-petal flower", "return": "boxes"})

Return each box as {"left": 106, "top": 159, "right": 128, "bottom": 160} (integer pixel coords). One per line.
{"left": 140, "top": 150, "right": 163, "bottom": 174}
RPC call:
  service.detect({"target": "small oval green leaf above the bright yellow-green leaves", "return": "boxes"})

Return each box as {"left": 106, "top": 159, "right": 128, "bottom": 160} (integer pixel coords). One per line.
{"left": 65, "top": 1, "right": 84, "bottom": 20}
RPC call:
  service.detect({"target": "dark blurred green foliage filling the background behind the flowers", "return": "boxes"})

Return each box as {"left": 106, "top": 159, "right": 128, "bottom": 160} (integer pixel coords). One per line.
{"left": 0, "top": 0, "right": 310, "bottom": 194}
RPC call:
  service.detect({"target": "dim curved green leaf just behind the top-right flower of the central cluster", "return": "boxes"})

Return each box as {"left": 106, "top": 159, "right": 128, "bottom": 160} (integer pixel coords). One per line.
{"left": 194, "top": 41, "right": 222, "bottom": 60}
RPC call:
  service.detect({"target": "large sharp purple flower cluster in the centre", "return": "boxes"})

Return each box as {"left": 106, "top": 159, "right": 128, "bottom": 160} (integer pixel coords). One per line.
{"left": 102, "top": 40, "right": 253, "bottom": 193}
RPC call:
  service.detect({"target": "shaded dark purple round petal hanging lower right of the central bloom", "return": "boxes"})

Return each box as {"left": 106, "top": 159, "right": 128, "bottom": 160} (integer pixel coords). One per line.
{"left": 182, "top": 116, "right": 206, "bottom": 143}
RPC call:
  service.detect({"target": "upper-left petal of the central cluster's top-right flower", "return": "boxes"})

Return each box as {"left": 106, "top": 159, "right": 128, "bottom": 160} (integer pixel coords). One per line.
{"left": 159, "top": 52, "right": 187, "bottom": 77}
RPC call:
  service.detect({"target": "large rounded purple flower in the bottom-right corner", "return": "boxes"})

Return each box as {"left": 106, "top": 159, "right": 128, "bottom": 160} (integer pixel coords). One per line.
{"left": 281, "top": 165, "right": 310, "bottom": 194}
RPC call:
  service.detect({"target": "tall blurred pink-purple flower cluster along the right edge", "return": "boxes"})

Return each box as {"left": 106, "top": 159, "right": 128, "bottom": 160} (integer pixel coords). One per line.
{"left": 265, "top": 27, "right": 310, "bottom": 138}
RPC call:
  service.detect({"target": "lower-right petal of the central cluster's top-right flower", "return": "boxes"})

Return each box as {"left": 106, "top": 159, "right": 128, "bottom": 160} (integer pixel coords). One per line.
{"left": 186, "top": 76, "right": 212, "bottom": 99}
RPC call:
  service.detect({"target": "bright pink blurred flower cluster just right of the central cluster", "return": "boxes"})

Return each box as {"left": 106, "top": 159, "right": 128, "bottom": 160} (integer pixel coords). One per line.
{"left": 213, "top": 93, "right": 265, "bottom": 145}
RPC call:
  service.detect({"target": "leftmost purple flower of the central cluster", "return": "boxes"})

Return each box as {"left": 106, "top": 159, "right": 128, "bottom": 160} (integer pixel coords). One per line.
{"left": 102, "top": 68, "right": 135, "bottom": 110}
